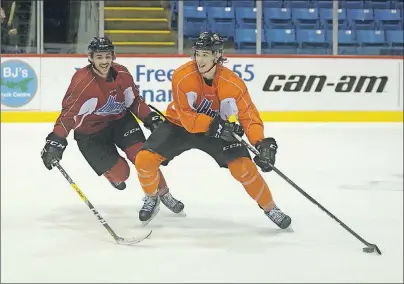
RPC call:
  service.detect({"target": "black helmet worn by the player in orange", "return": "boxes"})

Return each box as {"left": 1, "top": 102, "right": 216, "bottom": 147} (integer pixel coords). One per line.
{"left": 192, "top": 32, "right": 224, "bottom": 62}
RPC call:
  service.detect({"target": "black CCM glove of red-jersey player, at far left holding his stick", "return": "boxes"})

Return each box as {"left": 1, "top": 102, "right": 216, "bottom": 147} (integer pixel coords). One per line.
{"left": 41, "top": 132, "right": 67, "bottom": 170}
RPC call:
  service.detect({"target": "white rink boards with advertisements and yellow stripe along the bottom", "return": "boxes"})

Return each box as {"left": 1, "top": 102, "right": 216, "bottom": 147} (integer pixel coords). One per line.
{"left": 1, "top": 55, "right": 404, "bottom": 122}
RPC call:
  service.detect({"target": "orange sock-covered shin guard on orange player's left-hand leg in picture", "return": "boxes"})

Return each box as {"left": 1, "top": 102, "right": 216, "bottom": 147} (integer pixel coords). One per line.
{"left": 135, "top": 150, "right": 165, "bottom": 196}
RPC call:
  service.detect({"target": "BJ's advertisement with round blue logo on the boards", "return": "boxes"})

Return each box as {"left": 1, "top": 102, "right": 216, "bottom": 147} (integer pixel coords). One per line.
{"left": 0, "top": 58, "right": 41, "bottom": 111}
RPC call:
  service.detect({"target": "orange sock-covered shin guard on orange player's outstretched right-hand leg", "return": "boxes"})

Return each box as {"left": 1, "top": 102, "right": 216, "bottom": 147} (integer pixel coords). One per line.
{"left": 227, "top": 157, "right": 274, "bottom": 211}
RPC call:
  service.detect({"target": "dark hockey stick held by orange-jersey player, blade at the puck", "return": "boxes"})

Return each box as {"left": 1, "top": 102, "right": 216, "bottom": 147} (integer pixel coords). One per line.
{"left": 233, "top": 133, "right": 382, "bottom": 255}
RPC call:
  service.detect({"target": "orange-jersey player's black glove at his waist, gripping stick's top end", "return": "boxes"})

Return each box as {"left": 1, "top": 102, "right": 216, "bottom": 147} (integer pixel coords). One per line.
{"left": 206, "top": 115, "right": 244, "bottom": 142}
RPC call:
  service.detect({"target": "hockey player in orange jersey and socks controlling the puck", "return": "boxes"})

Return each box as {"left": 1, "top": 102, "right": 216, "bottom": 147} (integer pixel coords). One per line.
{"left": 135, "top": 32, "right": 291, "bottom": 229}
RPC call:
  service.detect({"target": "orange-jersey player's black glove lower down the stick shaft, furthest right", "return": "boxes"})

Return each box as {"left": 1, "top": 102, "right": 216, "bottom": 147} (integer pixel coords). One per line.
{"left": 254, "top": 138, "right": 278, "bottom": 173}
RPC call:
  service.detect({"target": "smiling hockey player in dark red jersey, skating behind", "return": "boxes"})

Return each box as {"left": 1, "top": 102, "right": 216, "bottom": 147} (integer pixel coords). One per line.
{"left": 41, "top": 37, "right": 184, "bottom": 220}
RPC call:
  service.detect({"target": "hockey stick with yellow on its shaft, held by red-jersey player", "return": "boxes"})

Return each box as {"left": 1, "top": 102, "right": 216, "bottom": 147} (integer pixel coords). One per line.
{"left": 52, "top": 160, "right": 152, "bottom": 245}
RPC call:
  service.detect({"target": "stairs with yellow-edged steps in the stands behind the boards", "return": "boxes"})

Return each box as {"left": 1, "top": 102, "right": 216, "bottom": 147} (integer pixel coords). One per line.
{"left": 104, "top": 1, "right": 177, "bottom": 53}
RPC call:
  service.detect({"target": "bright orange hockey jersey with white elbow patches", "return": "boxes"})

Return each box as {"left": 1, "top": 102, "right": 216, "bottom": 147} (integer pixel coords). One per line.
{"left": 166, "top": 61, "right": 264, "bottom": 145}
